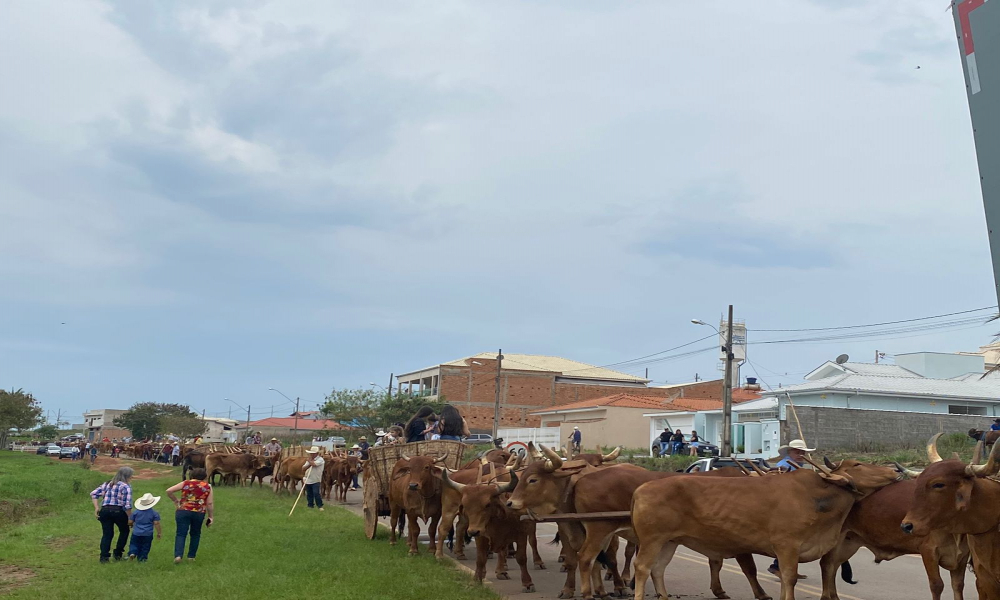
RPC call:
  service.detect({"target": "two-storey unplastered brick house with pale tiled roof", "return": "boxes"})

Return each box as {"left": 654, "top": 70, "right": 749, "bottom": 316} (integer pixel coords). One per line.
{"left": 396, "top": 352, "right": 722, "bottom": 431}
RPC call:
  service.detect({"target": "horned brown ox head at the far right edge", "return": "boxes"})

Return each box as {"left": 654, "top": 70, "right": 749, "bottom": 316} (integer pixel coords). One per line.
{"left": 900, "top": 433, "right": 1000, "bottom": 535}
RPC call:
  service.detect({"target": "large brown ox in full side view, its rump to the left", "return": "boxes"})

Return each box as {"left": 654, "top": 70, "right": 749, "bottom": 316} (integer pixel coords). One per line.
{"left": 632, "top": 460, "right": 899, "bottom": 600}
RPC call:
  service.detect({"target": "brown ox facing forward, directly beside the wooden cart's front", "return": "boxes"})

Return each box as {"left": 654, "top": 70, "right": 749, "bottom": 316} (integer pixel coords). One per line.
{"left": 389, "top": 453, "right": 448, "bottom": 554}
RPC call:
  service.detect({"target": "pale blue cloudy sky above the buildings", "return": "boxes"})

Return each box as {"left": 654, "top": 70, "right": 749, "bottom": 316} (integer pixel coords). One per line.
{"left": 0, "top": 0, "right": 1000, "bottom": 420}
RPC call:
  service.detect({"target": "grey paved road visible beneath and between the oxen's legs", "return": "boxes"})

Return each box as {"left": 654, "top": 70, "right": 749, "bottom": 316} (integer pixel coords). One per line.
{"left": 344, "top": 492, "right": 978, "bottom": 600}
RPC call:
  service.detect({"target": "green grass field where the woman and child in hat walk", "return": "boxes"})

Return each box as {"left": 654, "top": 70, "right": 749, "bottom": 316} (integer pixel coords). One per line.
{"left": 0, "top": 452, "right": 498, "bottom": 600}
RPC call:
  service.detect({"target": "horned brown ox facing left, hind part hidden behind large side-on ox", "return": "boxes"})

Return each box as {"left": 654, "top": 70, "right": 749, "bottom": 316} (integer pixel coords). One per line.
{"left": 507, "top": 447, "right": 768, "bottom": 599}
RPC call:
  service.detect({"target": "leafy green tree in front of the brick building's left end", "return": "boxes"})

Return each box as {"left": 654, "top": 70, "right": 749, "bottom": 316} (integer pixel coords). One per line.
{"left": 320, "top": 389, "right": 444, "bottom": 436}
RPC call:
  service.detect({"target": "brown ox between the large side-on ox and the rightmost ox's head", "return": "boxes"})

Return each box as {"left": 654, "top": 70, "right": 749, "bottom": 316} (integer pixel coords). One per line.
{"left": 820, "top": 480, "right": 969, "bottom": 600}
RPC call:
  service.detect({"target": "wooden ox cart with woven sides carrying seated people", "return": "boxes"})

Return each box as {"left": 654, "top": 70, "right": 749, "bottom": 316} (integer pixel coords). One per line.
{"left": 361, "top": 440, "right": 467, "bottom": 540}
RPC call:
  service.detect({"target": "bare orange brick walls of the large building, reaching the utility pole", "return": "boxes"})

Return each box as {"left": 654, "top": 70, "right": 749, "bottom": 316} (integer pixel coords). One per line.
{"left": 438, "top": 359, "right": 722, "bottom": 435}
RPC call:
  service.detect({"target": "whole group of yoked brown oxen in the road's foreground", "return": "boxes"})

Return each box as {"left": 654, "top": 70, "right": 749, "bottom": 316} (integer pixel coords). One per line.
{"left": 389, "top": 436, "right": 1000, "bottom": 600}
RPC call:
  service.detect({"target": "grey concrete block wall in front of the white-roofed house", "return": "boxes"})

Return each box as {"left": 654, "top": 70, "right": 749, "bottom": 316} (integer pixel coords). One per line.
{"left": 781, "top": 403, "right": 992, "bottom": 451}
